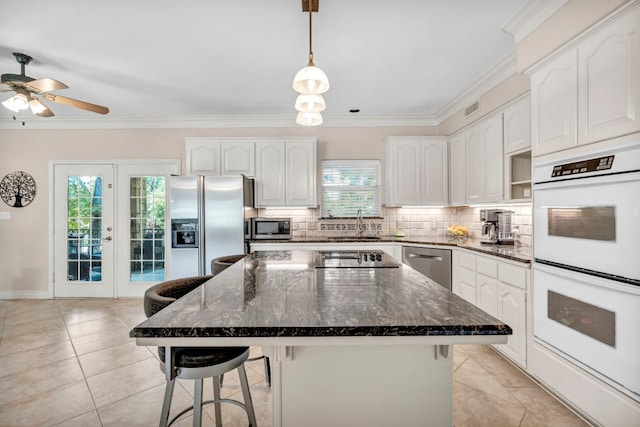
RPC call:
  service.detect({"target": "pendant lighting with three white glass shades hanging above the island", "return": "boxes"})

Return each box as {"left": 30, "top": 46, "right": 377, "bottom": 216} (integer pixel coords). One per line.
{"left": 293, "top": 0, "right": 329, "bottom": 126}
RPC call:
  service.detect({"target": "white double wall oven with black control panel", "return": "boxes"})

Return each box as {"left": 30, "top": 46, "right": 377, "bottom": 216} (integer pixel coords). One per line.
{"left": 533, "top": 141, "right": 640, "bottom": 400}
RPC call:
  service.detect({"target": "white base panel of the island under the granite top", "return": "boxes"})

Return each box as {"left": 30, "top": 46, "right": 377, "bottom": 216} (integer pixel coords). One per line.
{"left": 267, "top": 345, "right": 453, "bottom": 427}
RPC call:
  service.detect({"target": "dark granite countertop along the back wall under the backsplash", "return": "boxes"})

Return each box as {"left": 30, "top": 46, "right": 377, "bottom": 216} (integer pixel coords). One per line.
{"left": 251, "top": 236, "right": 532, "bottom": 264}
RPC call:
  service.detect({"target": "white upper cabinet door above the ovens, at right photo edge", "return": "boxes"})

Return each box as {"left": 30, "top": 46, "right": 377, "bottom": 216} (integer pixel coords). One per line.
{"left": 578, "top": 8, "right": 640, "bottom": 144}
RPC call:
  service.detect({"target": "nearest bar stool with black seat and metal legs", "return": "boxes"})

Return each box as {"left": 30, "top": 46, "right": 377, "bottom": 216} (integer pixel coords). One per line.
{"left": 144, "top": 276, "right": 257, "bottom": 427}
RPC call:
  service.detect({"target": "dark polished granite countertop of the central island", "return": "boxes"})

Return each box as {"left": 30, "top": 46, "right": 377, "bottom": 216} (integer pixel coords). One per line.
{"left": 130, "top": 251, "right": 511, "bottom": 338}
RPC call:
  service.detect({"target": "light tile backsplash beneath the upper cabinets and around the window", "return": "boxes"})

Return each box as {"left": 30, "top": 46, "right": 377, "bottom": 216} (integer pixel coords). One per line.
{"left": 258, "top": 204, "right": 532, "bottom": 246}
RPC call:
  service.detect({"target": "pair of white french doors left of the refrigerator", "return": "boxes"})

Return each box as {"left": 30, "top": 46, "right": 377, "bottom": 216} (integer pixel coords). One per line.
{"left": 53, "top": 161, "right": 179, "bottom": 298}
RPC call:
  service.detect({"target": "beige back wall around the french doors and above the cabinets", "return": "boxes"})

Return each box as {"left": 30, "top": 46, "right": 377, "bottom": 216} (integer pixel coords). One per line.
{"left": 0, "top": 125, "right": 435, "bottom": 297}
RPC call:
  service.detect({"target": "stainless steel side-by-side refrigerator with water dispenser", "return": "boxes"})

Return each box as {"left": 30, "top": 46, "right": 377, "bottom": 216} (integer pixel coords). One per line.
{"left": 169, "top": 176, "right": 253, "bottom": 279}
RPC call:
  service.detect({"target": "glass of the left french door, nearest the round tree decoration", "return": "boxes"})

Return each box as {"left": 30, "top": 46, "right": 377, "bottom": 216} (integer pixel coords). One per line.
{"left": 67, "top": 176, "right": 102, "bottom": 282}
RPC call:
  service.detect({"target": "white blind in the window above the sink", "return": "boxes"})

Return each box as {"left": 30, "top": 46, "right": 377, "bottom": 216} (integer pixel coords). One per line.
{"left": 320, "top": 160, "right": 382, "bottom": 218}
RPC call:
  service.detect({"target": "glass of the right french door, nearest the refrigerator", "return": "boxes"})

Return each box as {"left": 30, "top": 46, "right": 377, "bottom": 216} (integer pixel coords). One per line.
{"left": 129, "top": 176, "right": 166, "bottom": 282}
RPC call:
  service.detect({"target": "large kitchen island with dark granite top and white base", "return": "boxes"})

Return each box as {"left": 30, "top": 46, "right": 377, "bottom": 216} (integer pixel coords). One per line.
{"left": 131, "top": 251, "right": 511, "bottom": 426}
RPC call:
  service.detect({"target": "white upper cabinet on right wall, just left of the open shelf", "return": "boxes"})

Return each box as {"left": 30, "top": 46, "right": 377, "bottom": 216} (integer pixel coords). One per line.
{"left": 466, "top": 114, "right": 504, "bottom": 203}
